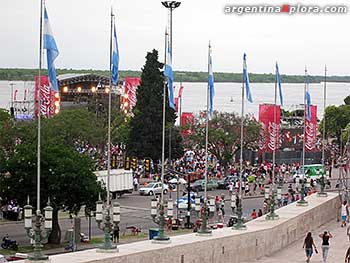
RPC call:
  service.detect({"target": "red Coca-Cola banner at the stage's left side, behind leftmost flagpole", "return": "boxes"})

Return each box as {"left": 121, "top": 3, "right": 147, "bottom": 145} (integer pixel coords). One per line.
{"left": 34, "top": 76, "right": 55, "bottom": 118}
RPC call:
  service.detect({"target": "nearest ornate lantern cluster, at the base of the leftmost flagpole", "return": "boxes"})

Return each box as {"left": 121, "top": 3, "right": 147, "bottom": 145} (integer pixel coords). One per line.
{"left": 24, "top": 197, "right": 53, "bottom": 262}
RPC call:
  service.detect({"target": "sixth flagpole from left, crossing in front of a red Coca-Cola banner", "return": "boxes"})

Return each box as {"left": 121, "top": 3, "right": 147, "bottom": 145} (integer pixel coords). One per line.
{"left": 266, "top": 62, "right": 278, "bottom": 220}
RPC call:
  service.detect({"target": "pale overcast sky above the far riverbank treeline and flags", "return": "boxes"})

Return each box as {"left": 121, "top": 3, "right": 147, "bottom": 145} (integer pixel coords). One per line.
{"left": 0, "top": 0, "right": 350, "bottom": 75}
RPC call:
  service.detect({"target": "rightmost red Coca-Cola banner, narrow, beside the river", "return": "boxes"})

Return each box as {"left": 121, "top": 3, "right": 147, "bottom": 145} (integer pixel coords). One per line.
{"left": 304, "top": 105, "right": 317, "bottom": 152}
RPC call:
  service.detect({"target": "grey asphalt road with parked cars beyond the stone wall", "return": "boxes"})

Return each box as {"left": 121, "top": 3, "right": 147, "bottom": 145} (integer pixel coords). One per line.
{"left": 0, "top": 190, "right": 263, "bottom": 248}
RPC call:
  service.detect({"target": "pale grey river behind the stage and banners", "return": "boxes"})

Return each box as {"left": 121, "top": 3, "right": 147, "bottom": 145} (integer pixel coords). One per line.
{"left": 0, "top": 81, "right": 350, "bottom": 118}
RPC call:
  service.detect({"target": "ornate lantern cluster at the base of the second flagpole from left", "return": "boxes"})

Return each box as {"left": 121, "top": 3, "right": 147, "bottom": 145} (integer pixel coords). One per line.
{"left": 96, "top": 198, "right": 120, "bottom": 252}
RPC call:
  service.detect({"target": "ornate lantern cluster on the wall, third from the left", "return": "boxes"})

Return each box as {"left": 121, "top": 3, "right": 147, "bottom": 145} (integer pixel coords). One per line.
{"left": 151, "top": 198, "right": 174, "bottom": 244}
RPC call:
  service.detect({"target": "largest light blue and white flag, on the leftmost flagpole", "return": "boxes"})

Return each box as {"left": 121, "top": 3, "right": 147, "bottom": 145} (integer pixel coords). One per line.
{"left": 44, "top": 7, "right": 59, "bottom": 91}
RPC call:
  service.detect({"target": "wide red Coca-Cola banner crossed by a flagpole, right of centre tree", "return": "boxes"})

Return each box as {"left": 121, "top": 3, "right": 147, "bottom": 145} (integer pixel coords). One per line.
{"left": 259, "top": 104, "right": 281, "bottom": 152}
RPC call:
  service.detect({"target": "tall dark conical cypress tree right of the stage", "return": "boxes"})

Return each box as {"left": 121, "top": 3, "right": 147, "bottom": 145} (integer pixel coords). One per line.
{"left": 127, "top": 49, "right": 182, "bottom": 161}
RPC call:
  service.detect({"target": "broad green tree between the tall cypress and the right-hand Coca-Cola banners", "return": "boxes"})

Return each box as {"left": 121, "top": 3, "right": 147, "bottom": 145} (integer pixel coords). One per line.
{"left": 185, "top": 112, "right": 260, "bottom": 172}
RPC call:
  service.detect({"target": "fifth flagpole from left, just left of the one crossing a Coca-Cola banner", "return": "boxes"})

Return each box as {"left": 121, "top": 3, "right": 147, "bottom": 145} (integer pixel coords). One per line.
{"left": 233, "top": 55, "right": 247, "bottom": 230}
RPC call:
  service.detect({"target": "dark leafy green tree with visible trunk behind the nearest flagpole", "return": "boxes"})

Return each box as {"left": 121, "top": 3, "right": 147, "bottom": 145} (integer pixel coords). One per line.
{"left": 0, "top": 143, "right": 104, "bottom": 243}
